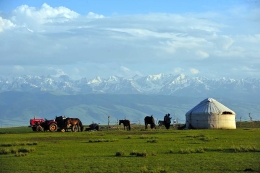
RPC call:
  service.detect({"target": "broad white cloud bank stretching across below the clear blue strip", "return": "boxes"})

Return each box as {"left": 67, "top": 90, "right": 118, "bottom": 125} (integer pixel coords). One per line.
{"left": 0, "top": 4, "right": 260, "bottom": 77}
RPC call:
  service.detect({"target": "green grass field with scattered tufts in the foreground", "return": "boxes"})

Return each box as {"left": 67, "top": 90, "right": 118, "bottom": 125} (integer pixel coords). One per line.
{"left": 0, "top": 124, "right": 260, "bottom": 173}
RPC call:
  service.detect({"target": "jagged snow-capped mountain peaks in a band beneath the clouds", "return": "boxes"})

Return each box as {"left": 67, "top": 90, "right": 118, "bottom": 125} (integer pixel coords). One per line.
{"left": 0, "top": 74, "right": 260, "bottom": 96}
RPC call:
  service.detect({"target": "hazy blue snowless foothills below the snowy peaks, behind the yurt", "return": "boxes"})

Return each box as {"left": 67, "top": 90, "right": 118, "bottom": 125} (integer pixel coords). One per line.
{"left": 0, "top": 91, "right": 260, "bottom": 127}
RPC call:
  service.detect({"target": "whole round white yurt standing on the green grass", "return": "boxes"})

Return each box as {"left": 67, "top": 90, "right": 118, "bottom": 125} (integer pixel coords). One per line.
{"left": 186, "top": 98, "right": 236, "bottom": 129}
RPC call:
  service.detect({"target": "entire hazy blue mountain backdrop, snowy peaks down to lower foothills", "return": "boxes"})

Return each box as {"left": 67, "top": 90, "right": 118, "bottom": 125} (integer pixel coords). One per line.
{"left": 0, "top": 74, "right": 260, "bottom": 126}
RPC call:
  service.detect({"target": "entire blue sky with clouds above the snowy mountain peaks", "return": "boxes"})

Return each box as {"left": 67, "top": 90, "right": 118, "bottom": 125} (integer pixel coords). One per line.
{"left": 0, "top": 0, "right": 260, "bottom": 79}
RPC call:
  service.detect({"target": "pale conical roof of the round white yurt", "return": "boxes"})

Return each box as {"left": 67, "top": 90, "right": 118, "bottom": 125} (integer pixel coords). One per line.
{"left": 186, "top": 98, "right": 235, "bottom": 115}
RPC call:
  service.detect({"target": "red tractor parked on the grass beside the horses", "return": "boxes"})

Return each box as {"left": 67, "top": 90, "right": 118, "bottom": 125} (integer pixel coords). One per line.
{"left": 29, "top": 118, "right": 58, "bottom": 132}
